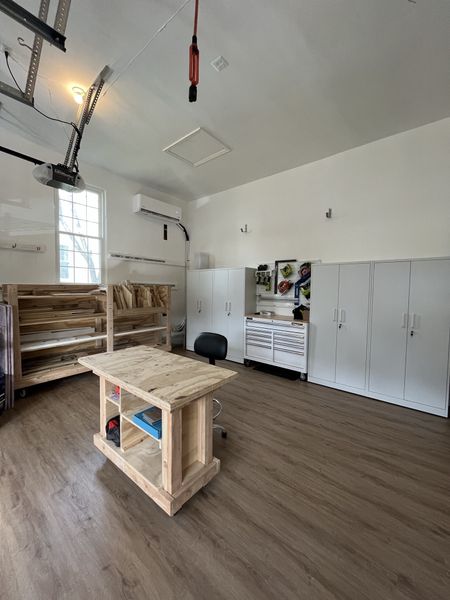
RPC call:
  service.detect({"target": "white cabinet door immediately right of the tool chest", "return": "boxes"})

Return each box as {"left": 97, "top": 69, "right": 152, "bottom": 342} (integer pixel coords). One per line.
{"left": 308, "top": 265, "right": 339, "bottom": 381}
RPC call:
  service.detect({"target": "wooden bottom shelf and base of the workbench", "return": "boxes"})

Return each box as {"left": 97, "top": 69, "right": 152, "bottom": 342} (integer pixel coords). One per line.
{"left": 94, "top": 433, "right": 220, "bottom": 516}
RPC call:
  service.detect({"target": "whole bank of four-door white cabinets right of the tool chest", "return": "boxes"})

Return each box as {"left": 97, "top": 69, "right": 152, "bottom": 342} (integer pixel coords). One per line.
{"left": 309, "top": 258, "right": 450, "bottom": 417}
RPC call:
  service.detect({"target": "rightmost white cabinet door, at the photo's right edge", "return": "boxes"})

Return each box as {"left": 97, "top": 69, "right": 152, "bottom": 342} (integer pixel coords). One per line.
{"left": 405, "top": 260, "right": 450, "bottom": 409}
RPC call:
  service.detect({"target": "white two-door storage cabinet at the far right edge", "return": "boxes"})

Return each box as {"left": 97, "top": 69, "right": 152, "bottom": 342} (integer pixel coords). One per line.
{"left": 368, "top": 259, "right": 450, "bottom": 417}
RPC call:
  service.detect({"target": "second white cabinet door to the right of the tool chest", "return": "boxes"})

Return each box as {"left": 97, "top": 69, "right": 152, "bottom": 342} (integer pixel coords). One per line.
{"left": 336, "top": 263, "right": 370, "bottom": 390}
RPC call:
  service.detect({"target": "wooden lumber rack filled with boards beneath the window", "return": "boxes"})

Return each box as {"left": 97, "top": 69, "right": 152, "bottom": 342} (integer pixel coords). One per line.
{"left": 2, "top": 282, "right": 171, "bottom": 390}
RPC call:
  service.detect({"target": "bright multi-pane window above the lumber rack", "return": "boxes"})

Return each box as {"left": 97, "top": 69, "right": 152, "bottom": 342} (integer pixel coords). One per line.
{"left": 57, "top": 189, "right": 103, "bottom": 283}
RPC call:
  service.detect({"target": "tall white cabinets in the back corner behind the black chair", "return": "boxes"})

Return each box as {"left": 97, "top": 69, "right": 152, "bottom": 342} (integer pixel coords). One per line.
{"left": 186, "top": 268, "right": 256, "bottom": 363}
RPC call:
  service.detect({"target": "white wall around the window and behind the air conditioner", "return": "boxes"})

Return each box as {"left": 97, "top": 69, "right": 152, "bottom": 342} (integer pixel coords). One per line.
{"left": 0, "top": 130, "right": 186, "bottom": 332}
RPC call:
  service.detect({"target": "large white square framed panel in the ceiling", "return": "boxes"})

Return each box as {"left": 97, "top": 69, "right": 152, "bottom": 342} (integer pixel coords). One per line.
{"left": 164, "top": 127, "right": 231, "bottom": 167}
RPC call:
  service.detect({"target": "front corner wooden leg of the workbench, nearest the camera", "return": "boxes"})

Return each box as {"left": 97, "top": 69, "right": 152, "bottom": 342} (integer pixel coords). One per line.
{"left": 161, "top": 408, "right": 182, "bottom": 494}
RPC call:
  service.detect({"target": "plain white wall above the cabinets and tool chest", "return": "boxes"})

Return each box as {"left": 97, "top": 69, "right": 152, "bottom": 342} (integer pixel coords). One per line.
{"left": 188, "top": 119, "right": 450, "bottom": 266}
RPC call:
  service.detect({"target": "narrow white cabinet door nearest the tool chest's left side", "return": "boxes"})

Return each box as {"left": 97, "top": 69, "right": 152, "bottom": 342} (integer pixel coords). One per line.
{"left": 227, "top": 269, "right": 245, "bottom": 362}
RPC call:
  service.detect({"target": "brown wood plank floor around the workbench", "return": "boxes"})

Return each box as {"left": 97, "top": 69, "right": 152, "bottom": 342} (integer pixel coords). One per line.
{"left": 0, "top": 354, "right": 450, "bottom": 600}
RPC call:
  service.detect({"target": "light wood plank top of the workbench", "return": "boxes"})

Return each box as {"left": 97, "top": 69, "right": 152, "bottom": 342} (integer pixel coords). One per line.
{"left": 79, "top": 346, "right": 237, "bottom": 411}
